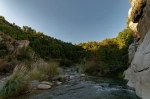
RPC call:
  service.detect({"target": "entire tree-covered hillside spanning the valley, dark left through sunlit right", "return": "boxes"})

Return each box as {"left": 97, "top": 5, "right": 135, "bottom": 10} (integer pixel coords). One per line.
{"left": 0, "top": 16, "right": 133, "bottom": 76}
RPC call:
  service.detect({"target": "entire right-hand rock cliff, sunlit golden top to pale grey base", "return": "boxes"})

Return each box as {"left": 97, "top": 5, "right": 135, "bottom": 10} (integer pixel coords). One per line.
{"left": 125, "top": 0, "right": 150, "bottom": 99}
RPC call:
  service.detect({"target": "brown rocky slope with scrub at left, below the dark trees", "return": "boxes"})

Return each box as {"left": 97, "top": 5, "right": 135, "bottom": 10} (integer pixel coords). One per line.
{"left": 0, "top": 32, "right": 47, "bottom": 73}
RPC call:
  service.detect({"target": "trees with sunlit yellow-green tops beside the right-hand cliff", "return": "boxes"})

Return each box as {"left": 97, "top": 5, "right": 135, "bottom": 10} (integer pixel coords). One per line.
{"left": 78, "top": 28, "right": 133, "bottom": 76}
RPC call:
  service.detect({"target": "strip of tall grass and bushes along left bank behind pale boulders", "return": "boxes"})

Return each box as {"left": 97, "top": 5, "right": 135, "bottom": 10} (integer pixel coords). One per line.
{"left": 0, "top": 63, "right": 58, "bottom": 99}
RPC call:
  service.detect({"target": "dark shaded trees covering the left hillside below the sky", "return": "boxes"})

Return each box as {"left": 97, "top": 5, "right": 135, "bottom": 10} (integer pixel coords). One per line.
{"left": 0, "top": 16, "right": 86, "bottom": 62}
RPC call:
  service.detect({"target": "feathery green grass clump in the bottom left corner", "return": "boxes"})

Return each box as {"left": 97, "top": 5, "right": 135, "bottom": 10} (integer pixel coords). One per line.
{"left": 0, "top": 66, "right": 28, "bottom": 98}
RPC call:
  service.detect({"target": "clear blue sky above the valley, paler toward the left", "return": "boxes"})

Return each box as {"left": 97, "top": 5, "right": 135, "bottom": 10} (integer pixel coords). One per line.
{"left": 0, "top": 0, "right": 130, "bottom": 44}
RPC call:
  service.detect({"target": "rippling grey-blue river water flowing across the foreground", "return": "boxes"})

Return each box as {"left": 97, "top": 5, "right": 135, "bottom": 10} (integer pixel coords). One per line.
{"left": 18, "top": 71, "right": 140, "bottom": 99}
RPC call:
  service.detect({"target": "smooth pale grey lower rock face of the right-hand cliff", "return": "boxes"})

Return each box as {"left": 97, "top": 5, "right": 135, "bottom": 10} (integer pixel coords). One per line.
{"left": 125, "top": 31, "right": 150, "bottom": 99}
